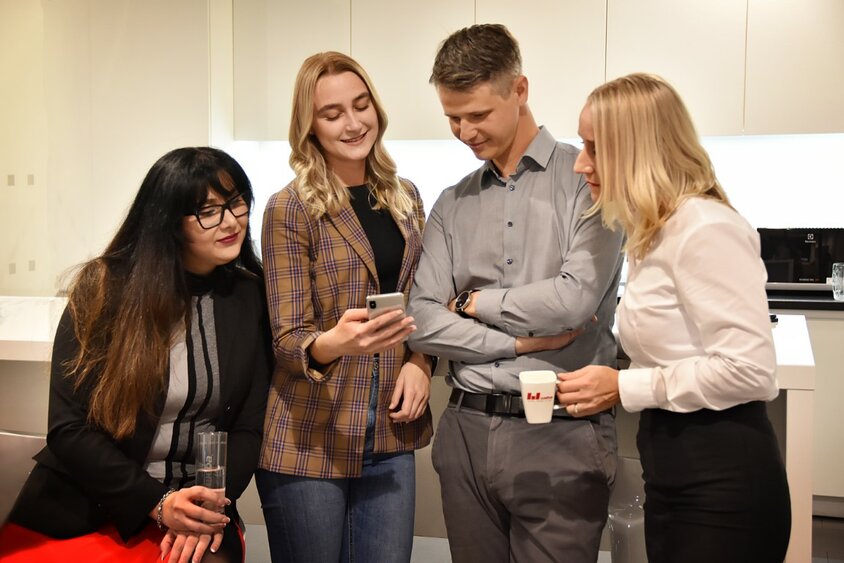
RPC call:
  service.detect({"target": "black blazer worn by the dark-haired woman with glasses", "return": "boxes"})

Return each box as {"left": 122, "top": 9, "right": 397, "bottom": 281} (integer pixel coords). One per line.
{"left": 10, "top": 271, "right": 272, "bottom": 541}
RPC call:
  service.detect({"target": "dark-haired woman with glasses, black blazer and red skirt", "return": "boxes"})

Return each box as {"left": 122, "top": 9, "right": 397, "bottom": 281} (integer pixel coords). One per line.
{"left": 0, "top": 147, "right": 272, "bottom": 563}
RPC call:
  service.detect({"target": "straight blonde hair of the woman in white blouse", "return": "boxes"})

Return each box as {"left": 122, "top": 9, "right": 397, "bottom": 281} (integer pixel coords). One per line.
{"left": 587, "top": 73, "right": 729, "bottom": 259}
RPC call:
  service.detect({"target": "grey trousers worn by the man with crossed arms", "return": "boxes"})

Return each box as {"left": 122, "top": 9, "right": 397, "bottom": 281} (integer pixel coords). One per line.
{"left": 432, "top": 406, "right": 616, "bottom": 563}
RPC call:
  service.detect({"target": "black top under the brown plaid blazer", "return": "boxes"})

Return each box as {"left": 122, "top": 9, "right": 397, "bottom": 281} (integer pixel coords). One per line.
{"left": 349, "top": 185, "right": 404, "bottom": 293}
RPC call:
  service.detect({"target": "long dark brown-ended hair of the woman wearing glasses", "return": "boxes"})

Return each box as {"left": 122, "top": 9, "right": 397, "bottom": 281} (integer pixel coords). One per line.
{"left": 67, "top": 147, "right": 263, "bottom": 439}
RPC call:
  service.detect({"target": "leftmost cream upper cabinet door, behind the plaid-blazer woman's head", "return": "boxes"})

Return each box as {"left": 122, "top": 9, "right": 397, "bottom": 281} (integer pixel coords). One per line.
{"left": 233, "top": 0, "right": 350, "bottom": 141}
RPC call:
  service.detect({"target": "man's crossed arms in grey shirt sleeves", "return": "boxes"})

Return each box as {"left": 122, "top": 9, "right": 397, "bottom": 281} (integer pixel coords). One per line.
{"left": 410, "top": 189, "right": 622, "bottom": 363}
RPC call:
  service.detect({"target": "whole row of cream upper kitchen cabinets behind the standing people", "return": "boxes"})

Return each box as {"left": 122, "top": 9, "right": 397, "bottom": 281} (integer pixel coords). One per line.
{"left": 232, "top": 0, "right": 844, "bottom": 140}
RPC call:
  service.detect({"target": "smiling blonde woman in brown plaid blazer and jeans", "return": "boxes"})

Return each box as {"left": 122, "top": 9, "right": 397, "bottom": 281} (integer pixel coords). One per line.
{"left": 256, "top": 52, "right": 432, "bottom": 563}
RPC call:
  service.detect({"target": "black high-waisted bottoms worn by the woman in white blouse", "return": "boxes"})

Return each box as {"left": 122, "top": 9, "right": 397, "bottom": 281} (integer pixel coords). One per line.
{"left": 637, "top": 402, "right": 791, "bottom": 563}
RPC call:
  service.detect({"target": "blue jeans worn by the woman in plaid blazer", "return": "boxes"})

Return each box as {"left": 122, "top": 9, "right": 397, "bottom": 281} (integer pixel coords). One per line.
{"left": 255, "top": 363, "right": 416, "bottom": 563}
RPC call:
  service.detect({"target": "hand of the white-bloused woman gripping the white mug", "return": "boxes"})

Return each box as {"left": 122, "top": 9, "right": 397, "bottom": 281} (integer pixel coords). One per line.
{"left": 557, "top": 366, "right": 621, "bottom": 417}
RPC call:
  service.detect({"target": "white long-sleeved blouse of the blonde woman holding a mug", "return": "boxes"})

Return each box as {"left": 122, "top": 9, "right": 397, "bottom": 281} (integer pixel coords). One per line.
{"left": 618, "top": 198, "right": 777, "bottom": 412}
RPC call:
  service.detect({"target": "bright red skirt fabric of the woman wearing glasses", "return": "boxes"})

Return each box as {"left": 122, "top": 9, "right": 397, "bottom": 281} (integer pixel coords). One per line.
{"left": 0, "top": 522, "right": 164, "bottom": 563}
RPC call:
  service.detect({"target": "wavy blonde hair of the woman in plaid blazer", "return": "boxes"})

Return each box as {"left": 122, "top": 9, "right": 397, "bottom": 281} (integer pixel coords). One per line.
{"left": 289, "top": 51, "right": 414, "bottom": 219}
